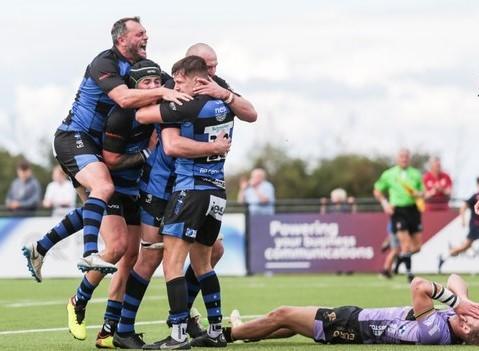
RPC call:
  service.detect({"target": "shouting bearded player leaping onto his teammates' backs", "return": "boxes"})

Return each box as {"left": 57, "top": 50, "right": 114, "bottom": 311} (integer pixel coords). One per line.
{"left": 23, "top": 17, "right": 190, "bottom": 281}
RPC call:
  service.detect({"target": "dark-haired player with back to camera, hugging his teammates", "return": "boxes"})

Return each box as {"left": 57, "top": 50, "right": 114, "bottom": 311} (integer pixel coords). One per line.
{"left": 136, "top": 56, "right": 257, "bottom": 349}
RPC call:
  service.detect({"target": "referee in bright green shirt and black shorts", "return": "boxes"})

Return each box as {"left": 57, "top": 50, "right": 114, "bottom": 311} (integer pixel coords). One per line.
{"left": 374, "top": 149, "right": 423, "bottom": 281}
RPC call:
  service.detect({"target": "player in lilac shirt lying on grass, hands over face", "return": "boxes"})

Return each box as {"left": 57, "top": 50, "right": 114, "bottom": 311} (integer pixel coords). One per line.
{"left": 224, "top": 274, "right": 479, "bottom": 345}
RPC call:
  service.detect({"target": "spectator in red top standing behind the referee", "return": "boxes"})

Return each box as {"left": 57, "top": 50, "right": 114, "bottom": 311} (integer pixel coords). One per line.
{"left": 423, "top": 156, "right": 452, "bottom": 211}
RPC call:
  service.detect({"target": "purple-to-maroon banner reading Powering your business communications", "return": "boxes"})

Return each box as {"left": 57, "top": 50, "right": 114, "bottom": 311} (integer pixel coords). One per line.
{"left": 249, "top": 210, "right": 457, "bottom": 273}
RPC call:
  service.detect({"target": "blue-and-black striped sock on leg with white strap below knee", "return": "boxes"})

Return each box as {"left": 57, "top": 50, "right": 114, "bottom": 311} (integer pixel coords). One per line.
{"left": 116, "top": 270, "right": 150, "bottom": 336}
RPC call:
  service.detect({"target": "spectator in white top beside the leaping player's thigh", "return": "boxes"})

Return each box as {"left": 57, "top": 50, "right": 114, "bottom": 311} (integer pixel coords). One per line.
{"left": 43, "top": 166, "right": 76, "bottom": 217}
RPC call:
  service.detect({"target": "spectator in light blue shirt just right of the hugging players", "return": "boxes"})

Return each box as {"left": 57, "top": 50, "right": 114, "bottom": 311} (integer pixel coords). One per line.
{"left": 238, "top": 168, "right": 275, "bottom": 215}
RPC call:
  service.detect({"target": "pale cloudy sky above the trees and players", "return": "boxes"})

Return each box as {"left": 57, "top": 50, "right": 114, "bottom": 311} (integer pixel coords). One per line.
{"left": 0, "top": 0, "right": 479, "bottom": 196}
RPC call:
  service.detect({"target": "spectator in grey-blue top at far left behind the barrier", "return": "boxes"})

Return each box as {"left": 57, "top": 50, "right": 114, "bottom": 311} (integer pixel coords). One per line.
{"left": 6, "top": 160, "right": 42, "bottom": 212}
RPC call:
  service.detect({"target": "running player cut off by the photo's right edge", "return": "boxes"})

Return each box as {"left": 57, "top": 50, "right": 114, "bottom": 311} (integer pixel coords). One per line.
{"left": 438, "top": 177, "right": 479, "bottom": 273}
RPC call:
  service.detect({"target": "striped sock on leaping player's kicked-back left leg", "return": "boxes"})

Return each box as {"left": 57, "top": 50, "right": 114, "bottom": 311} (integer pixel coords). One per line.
{"left": 37, "top": 207, "right": 83, "bottom": 256}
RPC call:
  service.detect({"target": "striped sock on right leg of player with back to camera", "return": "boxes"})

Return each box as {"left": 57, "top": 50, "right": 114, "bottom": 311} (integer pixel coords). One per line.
{"left": 198, "top": 270, "right": 223, "bottom": 338}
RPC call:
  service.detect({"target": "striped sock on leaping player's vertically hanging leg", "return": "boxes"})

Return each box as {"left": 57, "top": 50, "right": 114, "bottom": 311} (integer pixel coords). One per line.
{"left": 83, "top": 197, "right": 107, "bottom": 257}
